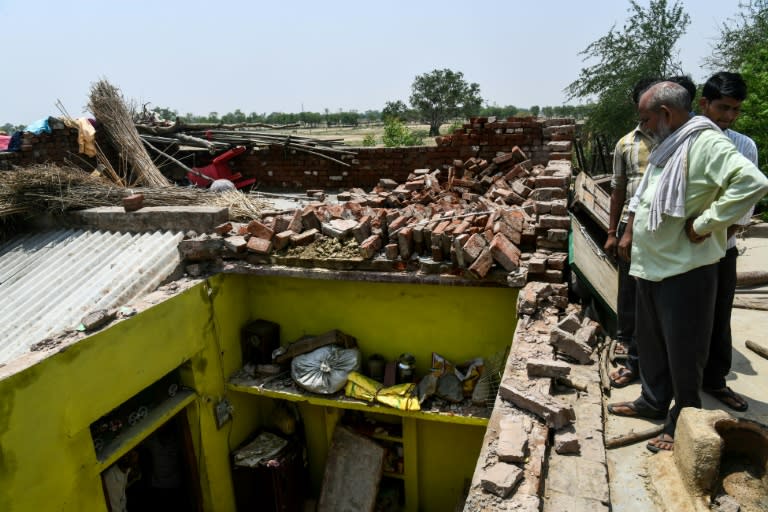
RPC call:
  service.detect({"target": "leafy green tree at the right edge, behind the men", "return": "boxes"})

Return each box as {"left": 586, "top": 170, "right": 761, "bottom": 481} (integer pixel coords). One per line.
{"left": 707, "top": 0, "right": 768, "bottom": 180}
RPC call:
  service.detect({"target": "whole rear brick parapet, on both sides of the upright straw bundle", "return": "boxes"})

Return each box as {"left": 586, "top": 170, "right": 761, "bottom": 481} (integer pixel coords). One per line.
{"left": 0, "top": 117, "right": 576, "bottom": 190}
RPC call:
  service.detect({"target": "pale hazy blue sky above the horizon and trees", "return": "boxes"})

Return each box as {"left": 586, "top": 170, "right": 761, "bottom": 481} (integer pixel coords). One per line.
{"left": 0, "top": 0, "right": 739, "bottom": 124}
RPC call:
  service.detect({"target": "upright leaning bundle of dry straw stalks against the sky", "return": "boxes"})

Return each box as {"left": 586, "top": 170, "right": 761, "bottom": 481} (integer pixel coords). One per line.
{"left": 88, "top": 80, "right": 170, "bottom": 187}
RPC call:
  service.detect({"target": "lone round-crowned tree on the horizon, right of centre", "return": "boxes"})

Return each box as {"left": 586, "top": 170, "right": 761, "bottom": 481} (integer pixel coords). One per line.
{"left": 410, "top": 69, "right": 483, "bottom": 136}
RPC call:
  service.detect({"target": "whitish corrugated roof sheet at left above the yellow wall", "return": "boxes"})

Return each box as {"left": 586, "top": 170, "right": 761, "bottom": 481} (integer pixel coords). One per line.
{"left": 0, "top": 229, "right": 183, "bottom": 363}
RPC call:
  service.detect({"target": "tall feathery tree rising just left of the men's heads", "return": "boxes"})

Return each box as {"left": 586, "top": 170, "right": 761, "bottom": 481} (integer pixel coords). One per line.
{"left": 565, "top": 0, "right": 690, "bottom": 142}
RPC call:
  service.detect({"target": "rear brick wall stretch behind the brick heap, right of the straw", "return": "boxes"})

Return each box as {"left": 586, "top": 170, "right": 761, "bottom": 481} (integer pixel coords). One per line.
{"left": 233, "top": 118, "right": 576, "bottom": 189}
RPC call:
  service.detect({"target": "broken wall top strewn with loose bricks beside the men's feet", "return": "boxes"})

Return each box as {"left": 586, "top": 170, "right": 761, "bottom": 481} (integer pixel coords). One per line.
{"left": 464, "top": 282, "right": 610, "bottom": 512}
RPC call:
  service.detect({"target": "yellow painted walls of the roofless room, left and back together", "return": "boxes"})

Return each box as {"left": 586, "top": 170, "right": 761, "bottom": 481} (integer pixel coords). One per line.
{"left": 0, "top": 275, "right": 517, "bottom": 512}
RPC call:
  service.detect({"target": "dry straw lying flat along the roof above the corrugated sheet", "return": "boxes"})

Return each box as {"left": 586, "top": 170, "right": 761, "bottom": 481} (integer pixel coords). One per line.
{"left": 0, "top": 164, "right": 270, "bottom": 221}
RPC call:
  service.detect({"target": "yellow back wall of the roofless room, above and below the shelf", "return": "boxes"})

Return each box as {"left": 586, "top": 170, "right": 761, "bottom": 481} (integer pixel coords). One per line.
{"left": 234, "top": 276, "right": 517, "bottom": 511}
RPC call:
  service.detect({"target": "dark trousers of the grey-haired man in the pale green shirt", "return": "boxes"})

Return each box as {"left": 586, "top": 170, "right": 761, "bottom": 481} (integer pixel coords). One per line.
{"left": 636, "top": 263, "right": 717, "bottom": 436}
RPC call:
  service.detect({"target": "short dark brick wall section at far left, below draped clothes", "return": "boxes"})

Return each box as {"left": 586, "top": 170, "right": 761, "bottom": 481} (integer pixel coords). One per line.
{"left": 0, "top": 117, "right": 82, "bottom": 170}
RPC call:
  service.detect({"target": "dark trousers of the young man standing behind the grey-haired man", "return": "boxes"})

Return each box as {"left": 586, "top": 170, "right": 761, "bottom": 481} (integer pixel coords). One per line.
{"left": 702, "top": 247, "right": 739, "bottom": 389}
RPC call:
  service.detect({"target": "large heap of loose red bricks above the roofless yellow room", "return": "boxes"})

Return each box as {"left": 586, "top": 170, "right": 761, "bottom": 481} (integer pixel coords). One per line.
{"left": 182, "top": 147, "right": 571, "bottom": 286}
